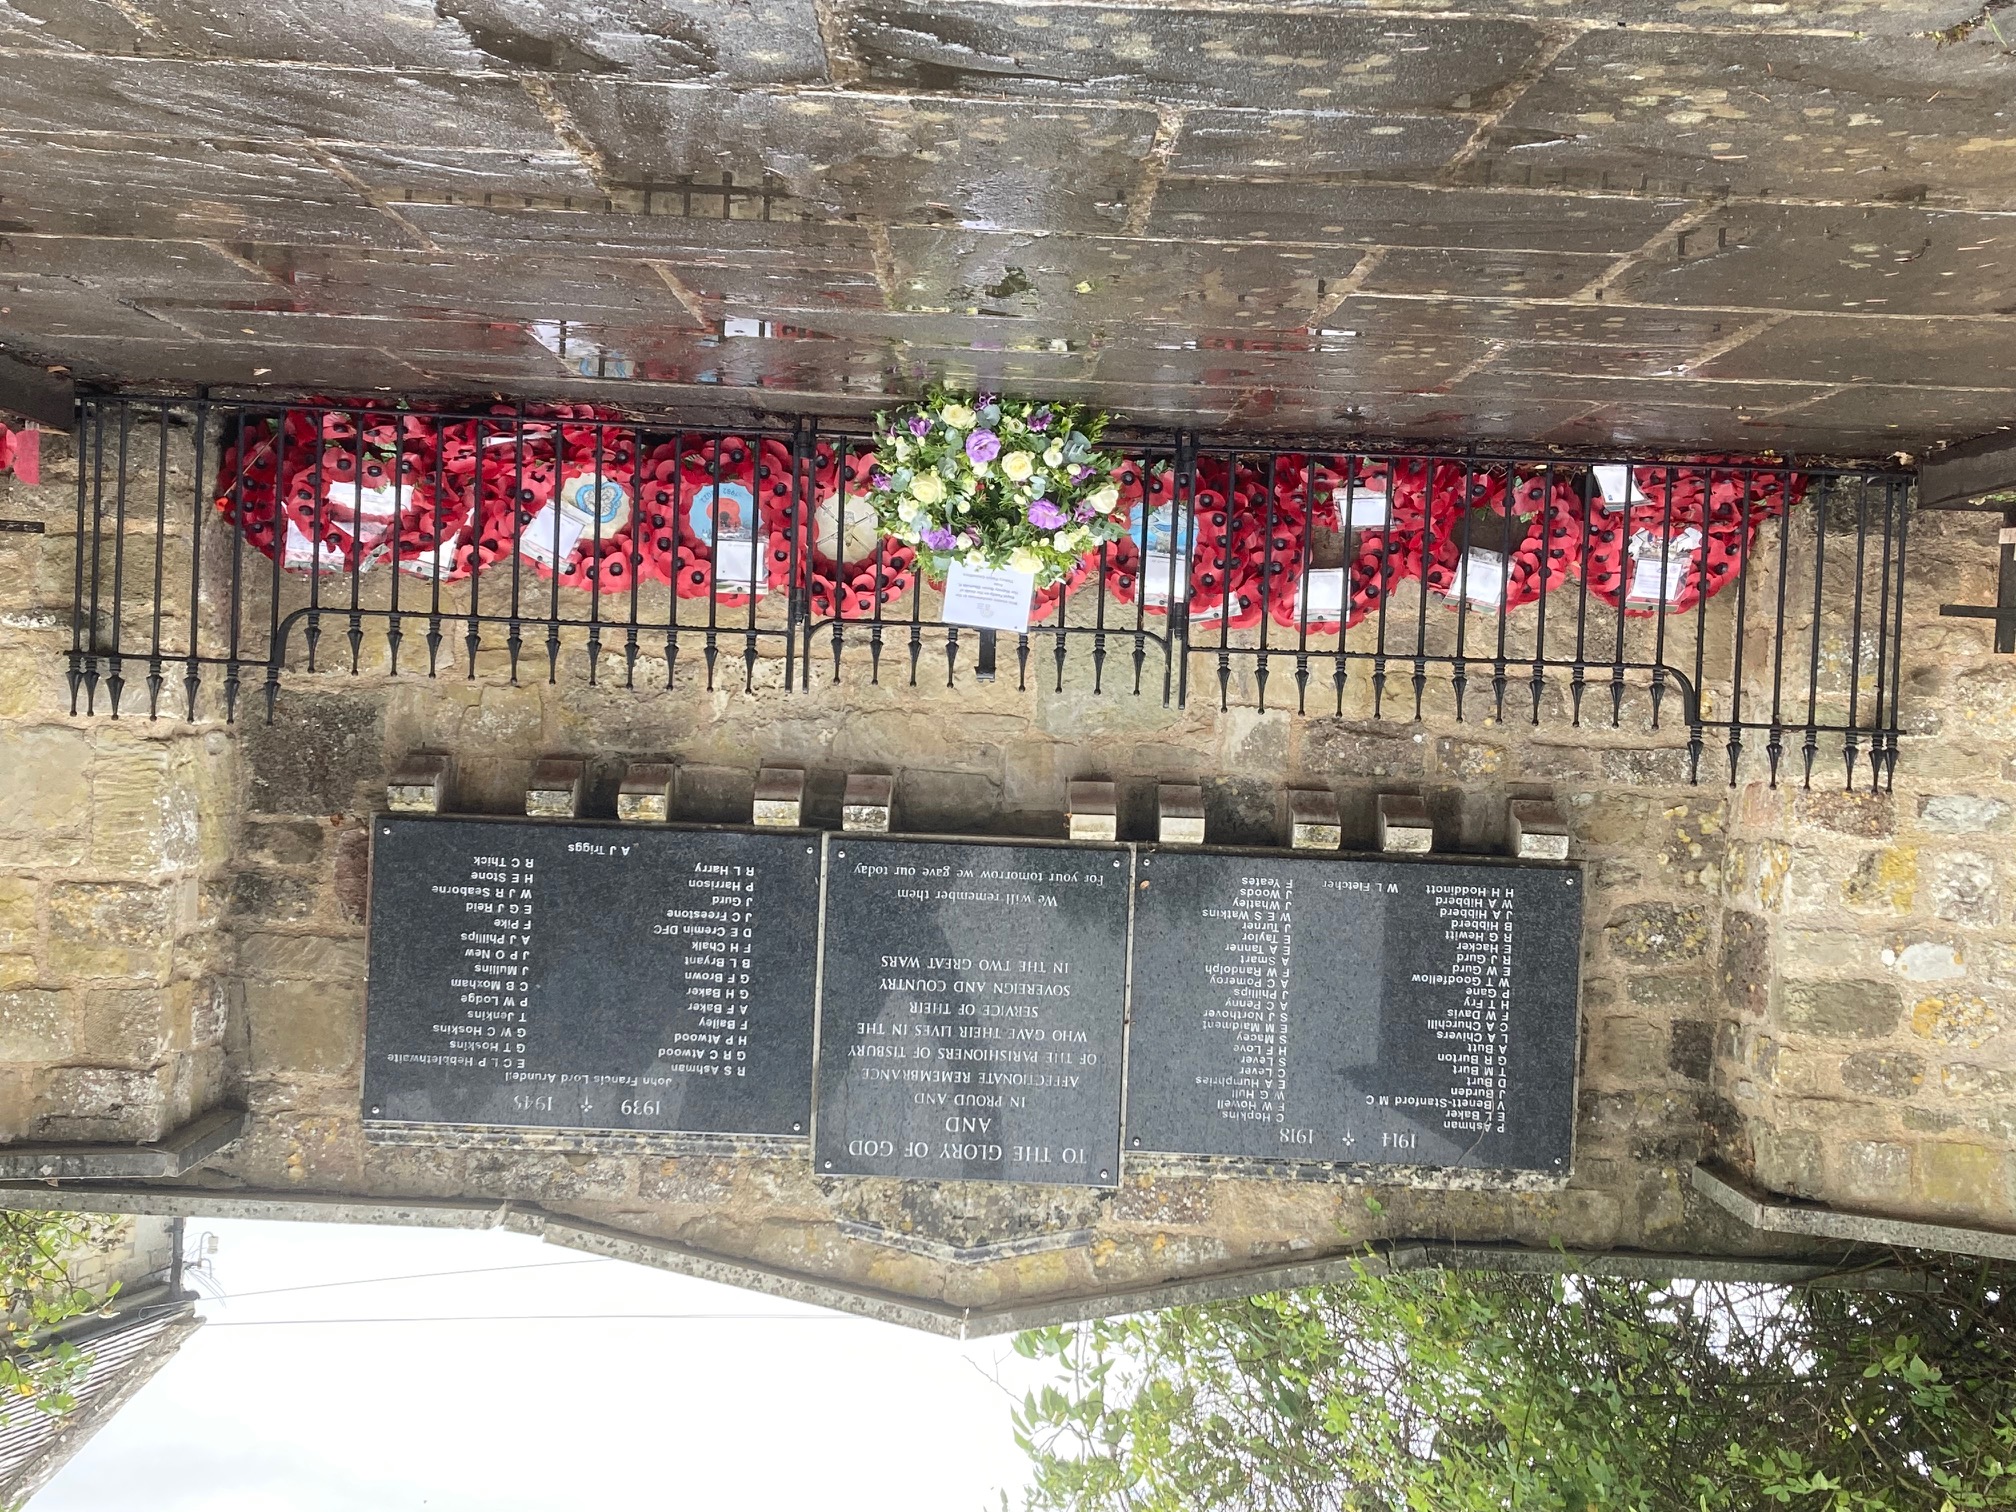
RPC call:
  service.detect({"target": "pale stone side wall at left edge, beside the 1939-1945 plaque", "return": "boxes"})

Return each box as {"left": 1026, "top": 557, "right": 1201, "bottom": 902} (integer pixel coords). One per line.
{"left": 0, "top": 435, "right": 238, "bottom": 1143}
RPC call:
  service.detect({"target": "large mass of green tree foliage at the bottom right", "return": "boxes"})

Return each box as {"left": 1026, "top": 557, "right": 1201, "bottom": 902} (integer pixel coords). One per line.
{"left": 1016, "top": 1264, "right": 2016, "bottom": 1512}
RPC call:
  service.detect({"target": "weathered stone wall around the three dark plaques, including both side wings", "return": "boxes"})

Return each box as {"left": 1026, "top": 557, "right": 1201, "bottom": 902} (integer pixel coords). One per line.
{"left": 0, "top": 411, "right": 2016, "bottom": 1304}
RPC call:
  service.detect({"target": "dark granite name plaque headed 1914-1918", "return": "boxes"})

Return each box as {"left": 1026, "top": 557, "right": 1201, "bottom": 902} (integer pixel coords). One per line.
{"left": 1127, "top": 851, "right": 1583, "bottom": 1175}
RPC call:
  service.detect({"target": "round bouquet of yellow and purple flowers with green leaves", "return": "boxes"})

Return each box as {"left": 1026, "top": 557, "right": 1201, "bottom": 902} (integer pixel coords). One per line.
{"left": 869, "top": 391, "right": 1127, "bottom": 589}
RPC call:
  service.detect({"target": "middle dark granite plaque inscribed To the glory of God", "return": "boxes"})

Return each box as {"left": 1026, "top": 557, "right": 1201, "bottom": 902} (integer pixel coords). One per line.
{"left": 812, "top": 835, "right": 1131, "bottom": 1185}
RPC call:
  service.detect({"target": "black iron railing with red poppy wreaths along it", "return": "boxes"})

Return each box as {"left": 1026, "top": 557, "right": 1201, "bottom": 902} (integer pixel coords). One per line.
{"left": 43, "top": 397, "right": 1911, "bottom": 786}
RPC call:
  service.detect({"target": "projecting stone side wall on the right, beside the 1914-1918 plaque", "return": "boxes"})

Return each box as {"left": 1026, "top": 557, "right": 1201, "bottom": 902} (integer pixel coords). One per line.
{"left": 1718, "top": 514, "right": 2016, "bottom": 1226}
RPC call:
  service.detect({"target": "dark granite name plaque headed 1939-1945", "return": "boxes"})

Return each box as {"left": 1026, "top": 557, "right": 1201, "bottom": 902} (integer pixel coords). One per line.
{"left": 365, "top": 830, "right": 818, "bottom": 1135}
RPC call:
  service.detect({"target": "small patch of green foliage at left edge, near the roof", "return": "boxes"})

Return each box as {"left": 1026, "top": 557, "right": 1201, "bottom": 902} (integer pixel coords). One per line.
{"left": 0, "top": 1212, "right": 119, "bottom": 1423}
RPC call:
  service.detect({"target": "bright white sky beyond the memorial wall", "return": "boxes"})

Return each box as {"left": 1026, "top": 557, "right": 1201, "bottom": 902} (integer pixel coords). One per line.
{"left": 30, "top": 1220, "right": 1040, "bottom": 1512}
